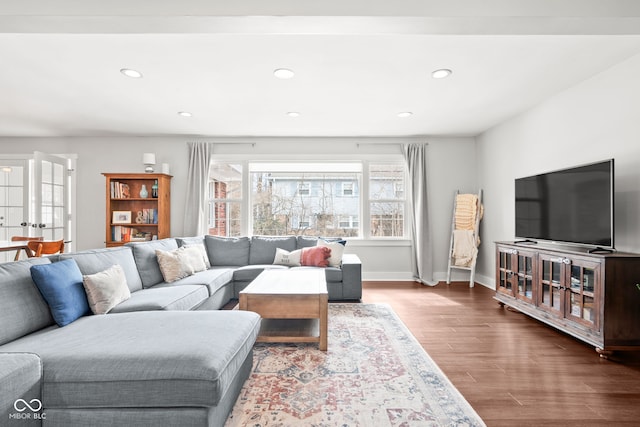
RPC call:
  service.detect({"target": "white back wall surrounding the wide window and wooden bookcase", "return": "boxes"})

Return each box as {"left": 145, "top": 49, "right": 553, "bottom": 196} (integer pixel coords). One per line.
{"left": 0, "top": 137, "right": 477, "bottom": 280}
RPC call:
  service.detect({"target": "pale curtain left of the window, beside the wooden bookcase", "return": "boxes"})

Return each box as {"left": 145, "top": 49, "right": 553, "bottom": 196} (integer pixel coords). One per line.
{"left": 184, "top": 142, "right": 213, "bottom": 236}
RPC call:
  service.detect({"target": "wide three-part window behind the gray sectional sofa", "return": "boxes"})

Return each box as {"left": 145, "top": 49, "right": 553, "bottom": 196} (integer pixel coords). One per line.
{"left": 208, "top": 161, "right": 406, "bottom": 238}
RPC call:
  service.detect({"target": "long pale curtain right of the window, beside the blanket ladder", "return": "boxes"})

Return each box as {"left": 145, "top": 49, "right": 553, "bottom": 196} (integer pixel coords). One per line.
{"left": 402, "top": 144, "right": 437, "bottom": 285}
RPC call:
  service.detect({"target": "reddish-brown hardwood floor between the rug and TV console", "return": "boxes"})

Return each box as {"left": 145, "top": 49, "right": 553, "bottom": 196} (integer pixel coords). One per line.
{"left": 362, "top": 282, "right": 640, "bottom": 427}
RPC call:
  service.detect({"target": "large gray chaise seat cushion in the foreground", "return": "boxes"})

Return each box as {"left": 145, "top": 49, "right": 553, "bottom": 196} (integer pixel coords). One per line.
{"left": 2, "top": 312, "right": 260, "bottom": 408}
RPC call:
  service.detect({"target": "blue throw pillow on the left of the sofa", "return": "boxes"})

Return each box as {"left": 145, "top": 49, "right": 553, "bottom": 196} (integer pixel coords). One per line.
{"left": 31, "top": 259, "right": 91, "bottom": 326}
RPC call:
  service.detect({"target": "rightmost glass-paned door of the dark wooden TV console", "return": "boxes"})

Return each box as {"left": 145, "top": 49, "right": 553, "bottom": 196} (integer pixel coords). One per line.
{"left": 566, "top": 260, "right": 600, "bottom": 328}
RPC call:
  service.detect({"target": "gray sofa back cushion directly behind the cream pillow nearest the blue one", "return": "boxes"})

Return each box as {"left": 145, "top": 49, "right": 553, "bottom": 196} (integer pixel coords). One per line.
{"left": 60, "top": 246, "right": 142, "bottom": 292}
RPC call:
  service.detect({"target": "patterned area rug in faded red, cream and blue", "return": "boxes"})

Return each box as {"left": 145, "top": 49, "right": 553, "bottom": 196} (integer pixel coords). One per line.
{"left": 226, "top": 303, "right": 484, "bottom": 427}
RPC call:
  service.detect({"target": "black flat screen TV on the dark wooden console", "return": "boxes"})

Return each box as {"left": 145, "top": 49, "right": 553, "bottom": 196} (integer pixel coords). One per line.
{"left": 515, "top": 159, "right": 614, "bottom": 249}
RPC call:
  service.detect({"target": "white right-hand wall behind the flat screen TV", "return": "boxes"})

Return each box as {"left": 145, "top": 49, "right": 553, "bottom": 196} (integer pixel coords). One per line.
{"left": 477, "top": 51, "right": 640, "bottom": 288}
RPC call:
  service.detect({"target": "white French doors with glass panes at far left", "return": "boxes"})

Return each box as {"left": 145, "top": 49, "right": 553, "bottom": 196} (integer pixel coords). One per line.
{"left": 0, "top": 152, "right": 73, "bottom": 262}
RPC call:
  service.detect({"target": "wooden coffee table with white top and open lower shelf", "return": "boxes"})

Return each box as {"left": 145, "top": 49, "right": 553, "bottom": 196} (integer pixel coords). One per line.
{"left": 240, "top": 268, "right": 328, "bottom": 351}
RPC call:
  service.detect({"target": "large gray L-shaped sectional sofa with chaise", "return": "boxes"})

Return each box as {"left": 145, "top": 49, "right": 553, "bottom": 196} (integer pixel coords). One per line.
{"left": 0, "top": 236, "right": 362, "bottom": 426}
